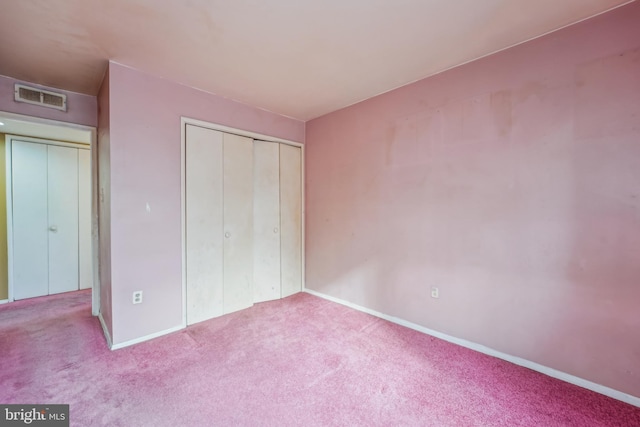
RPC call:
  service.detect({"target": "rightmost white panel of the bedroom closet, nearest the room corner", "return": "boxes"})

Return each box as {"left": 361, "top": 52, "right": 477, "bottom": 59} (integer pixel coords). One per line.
{"left": 280, "top": 144, "right": 302, "bottom": 297}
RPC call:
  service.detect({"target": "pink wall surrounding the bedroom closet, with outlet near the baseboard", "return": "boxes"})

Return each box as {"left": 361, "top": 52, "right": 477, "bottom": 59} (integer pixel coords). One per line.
{"left": 109, "top": 63, "right": 304, "bottom": 344}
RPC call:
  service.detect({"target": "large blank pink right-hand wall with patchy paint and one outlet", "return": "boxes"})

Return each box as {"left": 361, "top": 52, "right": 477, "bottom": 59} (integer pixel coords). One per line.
{"left": 306, "top": 2, "right": 640, "bottom": 396}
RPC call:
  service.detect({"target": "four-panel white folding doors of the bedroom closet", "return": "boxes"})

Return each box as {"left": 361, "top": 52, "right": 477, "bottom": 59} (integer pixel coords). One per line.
{"left": 184, "top": 124, "right": 302, "bottom": 324}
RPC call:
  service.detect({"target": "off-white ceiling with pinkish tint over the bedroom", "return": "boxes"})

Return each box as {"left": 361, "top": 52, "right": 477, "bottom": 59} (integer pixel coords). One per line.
{"left": 0, "top": 0, "right": 630, "bottom": 120}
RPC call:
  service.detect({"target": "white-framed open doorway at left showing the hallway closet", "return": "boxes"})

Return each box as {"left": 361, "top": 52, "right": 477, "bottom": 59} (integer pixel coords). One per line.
{"left": 0, "top": 112, "right": 100, "bottom": 315}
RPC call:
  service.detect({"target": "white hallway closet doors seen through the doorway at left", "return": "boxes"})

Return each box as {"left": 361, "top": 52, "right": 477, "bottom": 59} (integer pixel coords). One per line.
{"left": 7, "top": 137, "right": 92, "bottom": 300}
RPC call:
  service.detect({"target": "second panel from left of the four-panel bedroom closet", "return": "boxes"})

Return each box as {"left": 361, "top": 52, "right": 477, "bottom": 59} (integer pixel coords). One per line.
{"left": 223, "top": 133, "right": 253, "bottom": 313}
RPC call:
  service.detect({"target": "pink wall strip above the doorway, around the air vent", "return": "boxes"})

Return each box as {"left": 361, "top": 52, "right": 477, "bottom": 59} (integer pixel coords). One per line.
{"left": 0, "top": 76, "right": 98, "bottom": 127}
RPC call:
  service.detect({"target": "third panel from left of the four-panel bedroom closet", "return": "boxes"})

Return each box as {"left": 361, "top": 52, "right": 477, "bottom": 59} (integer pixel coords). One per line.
{"left": 253, "top": 141, "right": 280, "bottom": 302}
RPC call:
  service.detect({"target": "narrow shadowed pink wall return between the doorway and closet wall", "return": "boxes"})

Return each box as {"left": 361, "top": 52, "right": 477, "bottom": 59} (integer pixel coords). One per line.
{"left": 98, "top": 69, "right": 113, "bottom": 337}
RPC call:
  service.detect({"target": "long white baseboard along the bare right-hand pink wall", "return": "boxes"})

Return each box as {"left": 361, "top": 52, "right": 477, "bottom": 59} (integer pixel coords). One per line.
{"left": 305, "top": 289, "right": 640, "bottom": 407}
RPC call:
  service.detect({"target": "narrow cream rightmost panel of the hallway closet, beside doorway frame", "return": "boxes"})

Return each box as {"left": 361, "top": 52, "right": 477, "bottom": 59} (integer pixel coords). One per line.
{"left": 78, "top": 149, "right": 93, "bottom": 289}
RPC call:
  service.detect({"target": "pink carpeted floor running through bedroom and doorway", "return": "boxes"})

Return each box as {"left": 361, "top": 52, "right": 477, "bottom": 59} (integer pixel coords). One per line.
{"left": 0, "top": 291, "right": 640, "bottom": 427}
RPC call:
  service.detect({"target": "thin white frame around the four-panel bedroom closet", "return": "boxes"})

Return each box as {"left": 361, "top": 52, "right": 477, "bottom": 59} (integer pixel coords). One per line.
{"left": 180, "top": 116, "right": 305, "bottom": 327}
